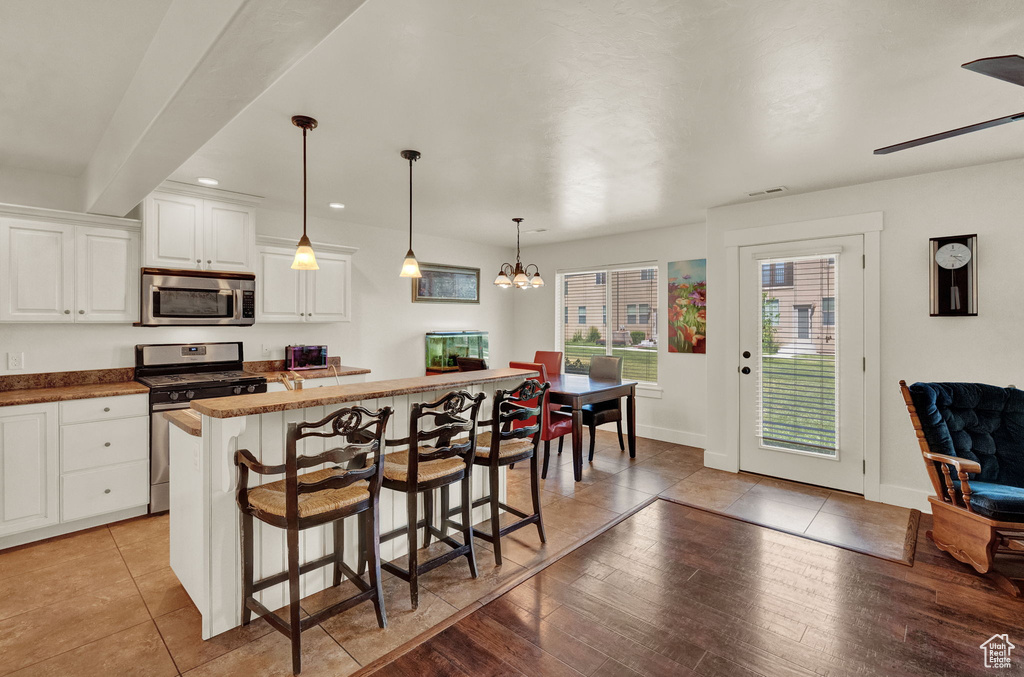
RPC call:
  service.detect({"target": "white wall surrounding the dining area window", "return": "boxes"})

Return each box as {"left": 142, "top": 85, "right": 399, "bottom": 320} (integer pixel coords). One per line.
{"left": 509, "top": 223, "right": 715, "bottom": 447}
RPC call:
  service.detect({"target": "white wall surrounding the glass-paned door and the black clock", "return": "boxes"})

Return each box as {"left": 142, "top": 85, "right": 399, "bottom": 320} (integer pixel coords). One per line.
{"left": 706, "top": 160, "right": 1024, "bottom": 508}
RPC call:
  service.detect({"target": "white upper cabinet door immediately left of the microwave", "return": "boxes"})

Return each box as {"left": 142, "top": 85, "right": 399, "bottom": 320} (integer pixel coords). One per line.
{"left": 75, "top": 226, "right": 141, "bottom": 323}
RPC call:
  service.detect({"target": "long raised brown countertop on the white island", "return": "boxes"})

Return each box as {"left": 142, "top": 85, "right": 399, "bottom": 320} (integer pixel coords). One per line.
{"left": 191, "top": 368, "right": 537, "bottom": 419}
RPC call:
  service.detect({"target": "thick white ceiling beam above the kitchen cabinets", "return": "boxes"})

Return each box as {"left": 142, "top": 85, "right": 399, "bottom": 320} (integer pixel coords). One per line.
{"left": 83, "top": 0, "right": 366, "bottom": 216}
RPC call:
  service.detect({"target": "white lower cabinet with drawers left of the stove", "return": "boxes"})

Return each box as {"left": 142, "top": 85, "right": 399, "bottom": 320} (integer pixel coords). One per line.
{"left": 0, "top": 394, "right": 150, "bottom": 548}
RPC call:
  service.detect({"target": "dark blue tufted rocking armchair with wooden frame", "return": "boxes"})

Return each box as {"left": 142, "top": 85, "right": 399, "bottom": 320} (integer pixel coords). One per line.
{"left": 899, "top": 381, "right": 1024, "bottom": 597}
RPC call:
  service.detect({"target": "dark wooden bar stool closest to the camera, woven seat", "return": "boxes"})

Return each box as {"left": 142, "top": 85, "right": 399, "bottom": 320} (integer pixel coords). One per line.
{"left": 234, "top": 407, "right": 391, "bottom": 674}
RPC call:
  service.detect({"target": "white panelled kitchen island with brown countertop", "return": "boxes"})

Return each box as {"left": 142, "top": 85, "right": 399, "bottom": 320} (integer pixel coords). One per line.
{"left": 170, "top": 369, "right": 537, "bottom": 639}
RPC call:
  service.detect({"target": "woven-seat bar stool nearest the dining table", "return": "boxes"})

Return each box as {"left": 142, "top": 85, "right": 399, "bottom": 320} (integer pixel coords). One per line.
{"left": 442, "top": 379, "right": 551, "bottom": 566}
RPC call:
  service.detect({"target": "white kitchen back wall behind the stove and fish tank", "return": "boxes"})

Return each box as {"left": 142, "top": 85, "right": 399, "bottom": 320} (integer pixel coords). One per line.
{"left": 0, "top": 209, "right": 514, "bottom": 380}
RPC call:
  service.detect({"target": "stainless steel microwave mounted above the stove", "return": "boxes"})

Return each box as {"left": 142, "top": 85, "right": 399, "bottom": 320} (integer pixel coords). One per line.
{"left": 138, "top": 268, "right": 256, "bottom": 327}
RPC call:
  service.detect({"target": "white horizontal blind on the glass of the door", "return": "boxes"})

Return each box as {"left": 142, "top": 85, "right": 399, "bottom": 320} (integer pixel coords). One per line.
{"left": 758, "top": 254, "right": 839, "bottom": 456}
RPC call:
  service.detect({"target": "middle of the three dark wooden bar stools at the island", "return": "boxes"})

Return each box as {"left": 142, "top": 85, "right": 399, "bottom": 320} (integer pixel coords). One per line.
{"left": 381, "top": 390, "right": 486, "bottom": 608}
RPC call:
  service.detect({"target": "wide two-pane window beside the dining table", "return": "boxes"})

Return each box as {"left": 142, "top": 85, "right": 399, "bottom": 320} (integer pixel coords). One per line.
{"left": 555, "top": 265, "right": 658, "bottom": 383}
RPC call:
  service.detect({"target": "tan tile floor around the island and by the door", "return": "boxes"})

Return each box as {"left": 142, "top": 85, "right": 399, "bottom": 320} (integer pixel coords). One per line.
{"left": 0, "top": 431, "right": 907, "bottom": 677}
